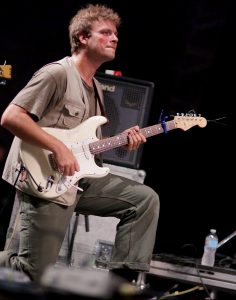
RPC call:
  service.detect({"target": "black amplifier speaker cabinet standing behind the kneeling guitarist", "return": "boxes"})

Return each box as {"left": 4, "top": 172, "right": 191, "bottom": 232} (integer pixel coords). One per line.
{"left": 96, "top": 73, "right": 154, "bottom": 169}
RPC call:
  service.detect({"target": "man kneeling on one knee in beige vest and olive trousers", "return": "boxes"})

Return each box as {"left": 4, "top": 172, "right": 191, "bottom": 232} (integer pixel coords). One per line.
{"left": 0, "top": 5, "right": 159, "bottom": 281}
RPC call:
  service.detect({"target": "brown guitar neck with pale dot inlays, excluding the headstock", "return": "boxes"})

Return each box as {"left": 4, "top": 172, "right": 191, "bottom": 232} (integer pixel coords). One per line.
{"left": 89, "top": 120, "right": 176, "bottom": 155}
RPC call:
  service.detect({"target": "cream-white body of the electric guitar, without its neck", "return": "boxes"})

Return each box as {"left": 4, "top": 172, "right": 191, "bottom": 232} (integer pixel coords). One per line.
{"left": 20, "top": 116, "right": 109, "bottom": 199}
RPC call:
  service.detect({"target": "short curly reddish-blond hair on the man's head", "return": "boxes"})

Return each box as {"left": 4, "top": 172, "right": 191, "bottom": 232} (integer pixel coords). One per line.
{"left": 69, "top": 4, "right": 121, "bottom": 54}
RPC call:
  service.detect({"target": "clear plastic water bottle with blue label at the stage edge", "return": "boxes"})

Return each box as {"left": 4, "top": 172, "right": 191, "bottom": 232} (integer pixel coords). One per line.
{"left": 201, "top": 229, "right": 218, "bottom": 267}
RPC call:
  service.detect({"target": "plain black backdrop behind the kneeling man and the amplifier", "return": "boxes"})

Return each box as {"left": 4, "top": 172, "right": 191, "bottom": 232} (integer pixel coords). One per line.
{"left": 0, "top": 0, "right": 236, "bottom": 257}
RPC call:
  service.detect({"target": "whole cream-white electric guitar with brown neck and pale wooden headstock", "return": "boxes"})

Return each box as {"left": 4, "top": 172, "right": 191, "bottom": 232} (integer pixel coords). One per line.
{"left": 20, "top": 115, "right": 207, "bottom": 199}
